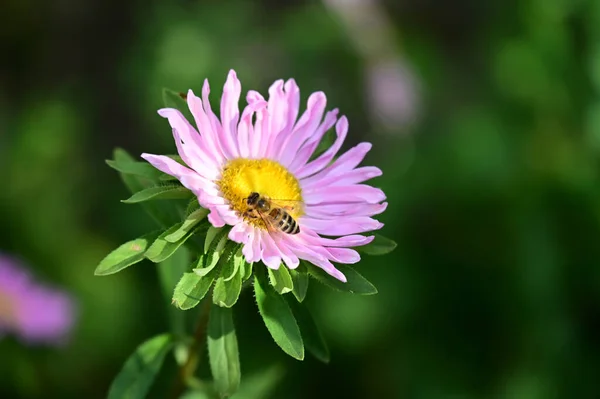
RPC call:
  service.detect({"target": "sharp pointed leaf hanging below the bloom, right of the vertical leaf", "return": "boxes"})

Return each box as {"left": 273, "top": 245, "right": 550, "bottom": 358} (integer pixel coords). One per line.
{"left": 254, "top": 271, "right": 304, "bottom": 360}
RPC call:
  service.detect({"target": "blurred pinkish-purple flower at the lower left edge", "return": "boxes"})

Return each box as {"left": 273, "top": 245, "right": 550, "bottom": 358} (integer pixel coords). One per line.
{"left": 0, "top": 254, "right": 75, "bottom": 345}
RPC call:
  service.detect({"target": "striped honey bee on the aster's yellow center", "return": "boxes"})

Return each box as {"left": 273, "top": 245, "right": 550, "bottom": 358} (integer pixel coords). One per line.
{"left": 244, "top": 192, "right": 300, "bottom": 234}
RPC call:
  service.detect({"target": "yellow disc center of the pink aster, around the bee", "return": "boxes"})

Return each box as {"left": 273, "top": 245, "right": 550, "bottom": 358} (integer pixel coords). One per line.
{"left": 217, "top": 158, "right": 303, "bottom": 229}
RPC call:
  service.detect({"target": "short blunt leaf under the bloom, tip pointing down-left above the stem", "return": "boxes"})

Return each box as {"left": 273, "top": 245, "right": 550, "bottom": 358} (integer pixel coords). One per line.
{"left": 172, "top": 254, "right": 219, "bottom": 310}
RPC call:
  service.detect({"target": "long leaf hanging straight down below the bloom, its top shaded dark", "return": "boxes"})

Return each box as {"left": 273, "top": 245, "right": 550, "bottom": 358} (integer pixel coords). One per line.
{"left": 208, "top": 305, "right": 241, "bottom": 398}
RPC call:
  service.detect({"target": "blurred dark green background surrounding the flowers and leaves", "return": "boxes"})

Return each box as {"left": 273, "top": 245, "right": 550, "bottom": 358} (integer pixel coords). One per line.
{"left": 0, "top": 0, "right": 600, "bottom": 399}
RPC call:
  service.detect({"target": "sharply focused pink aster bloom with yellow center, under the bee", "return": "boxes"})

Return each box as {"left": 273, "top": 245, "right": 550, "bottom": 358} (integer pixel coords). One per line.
{"left": 142, "top": 71, "right": 387, "bottom": 282}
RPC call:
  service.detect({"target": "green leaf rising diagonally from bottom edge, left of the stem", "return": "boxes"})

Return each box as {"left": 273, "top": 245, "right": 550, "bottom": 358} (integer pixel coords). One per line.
{"left": 108, "top": 334, "right": 173, "bottom": 399}
